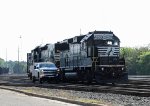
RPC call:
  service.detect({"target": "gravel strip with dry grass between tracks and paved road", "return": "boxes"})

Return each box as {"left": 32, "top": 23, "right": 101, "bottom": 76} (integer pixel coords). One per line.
{"left": 1, "top": 86, "right": 150, "bottom": 106}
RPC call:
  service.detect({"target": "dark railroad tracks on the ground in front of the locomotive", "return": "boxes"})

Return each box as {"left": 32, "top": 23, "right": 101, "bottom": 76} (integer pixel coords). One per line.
{"left": 0, "top": 76, "right": 150, "bottom": 97}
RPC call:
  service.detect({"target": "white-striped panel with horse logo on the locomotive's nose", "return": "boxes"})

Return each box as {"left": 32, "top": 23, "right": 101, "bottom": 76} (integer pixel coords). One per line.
{"left": 97, "top": 47, "right": 119, "bottom": 57}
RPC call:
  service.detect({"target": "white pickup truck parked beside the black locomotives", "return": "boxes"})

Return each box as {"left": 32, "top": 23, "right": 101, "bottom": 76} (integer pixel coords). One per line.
{"left": 32, "top": 62, "right": 60, "bottom": 83}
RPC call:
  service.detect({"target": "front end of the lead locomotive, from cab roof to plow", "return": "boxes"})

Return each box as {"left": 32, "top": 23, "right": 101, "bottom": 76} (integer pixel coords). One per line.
{"left": 81, "top": 31, "right": 128, "bottom": 83}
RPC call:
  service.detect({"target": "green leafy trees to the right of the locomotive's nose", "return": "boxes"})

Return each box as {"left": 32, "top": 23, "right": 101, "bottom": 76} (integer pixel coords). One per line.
{"left": 121, "top": 46, "right": 150, "bottom": 75}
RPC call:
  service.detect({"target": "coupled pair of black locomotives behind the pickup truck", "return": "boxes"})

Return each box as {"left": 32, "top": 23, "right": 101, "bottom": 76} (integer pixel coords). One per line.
{"left": 27, "top": 31, "right": 128, "bottom": 83}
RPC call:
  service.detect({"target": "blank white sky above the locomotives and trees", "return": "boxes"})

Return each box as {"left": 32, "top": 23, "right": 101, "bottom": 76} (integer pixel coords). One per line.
{"left": 0, "top": 0, "right": 150, "bottom": 61}
